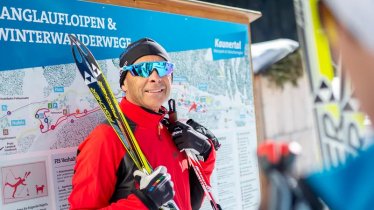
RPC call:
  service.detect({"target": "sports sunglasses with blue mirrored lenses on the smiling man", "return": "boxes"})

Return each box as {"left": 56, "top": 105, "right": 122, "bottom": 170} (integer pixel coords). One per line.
{"left": 121, "top": 61, "right": 174, "bottom": 78}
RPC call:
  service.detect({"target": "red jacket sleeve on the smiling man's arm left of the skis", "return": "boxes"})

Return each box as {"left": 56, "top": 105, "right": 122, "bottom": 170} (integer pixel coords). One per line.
{"left": 68, "top": 125, "right": 147, "bottom": 210}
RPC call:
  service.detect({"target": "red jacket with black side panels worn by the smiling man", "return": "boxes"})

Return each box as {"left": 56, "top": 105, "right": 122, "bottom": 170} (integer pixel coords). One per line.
{"left": 69, "top": 98, "right": 216, "bottom": 210}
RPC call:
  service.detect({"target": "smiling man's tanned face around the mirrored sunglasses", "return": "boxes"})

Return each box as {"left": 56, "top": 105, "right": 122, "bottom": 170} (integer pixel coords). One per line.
{"left": 121, "top": 55, "right": 171, "bottom": 112}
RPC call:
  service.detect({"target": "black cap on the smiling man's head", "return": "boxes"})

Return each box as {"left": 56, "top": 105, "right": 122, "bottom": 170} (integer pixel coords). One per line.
{"left": 119, "top": 38, "right": 170, "bottom": 86}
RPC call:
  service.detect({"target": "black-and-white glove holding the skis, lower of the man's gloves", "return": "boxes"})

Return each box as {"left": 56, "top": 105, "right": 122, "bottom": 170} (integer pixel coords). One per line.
{"left": 133, "top": 166, "right": 175, "bottom": 210}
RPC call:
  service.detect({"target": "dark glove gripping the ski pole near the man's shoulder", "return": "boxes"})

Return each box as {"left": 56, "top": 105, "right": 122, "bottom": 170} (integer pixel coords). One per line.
{"left": 170, "top": 121, "right": 211, "bottom": 159}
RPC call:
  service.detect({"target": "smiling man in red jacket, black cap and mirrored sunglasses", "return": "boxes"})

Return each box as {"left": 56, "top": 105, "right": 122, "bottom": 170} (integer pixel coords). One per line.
{"left": 69, "top": 38, "right": 216, "bottom": 210}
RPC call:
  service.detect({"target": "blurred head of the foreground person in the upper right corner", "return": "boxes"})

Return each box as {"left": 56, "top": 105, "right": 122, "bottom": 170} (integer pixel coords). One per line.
{"left": 319, "top": 0, "right": 374, "bottom": 120}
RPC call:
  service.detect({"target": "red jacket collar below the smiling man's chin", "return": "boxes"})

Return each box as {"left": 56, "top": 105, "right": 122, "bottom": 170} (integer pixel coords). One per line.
{"left": 120, "top": 97, "right": 166, "bottom": 127}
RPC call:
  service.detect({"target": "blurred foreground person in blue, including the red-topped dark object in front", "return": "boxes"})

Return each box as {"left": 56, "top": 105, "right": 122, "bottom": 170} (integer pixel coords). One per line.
{"left": 257, "top": 0, "right": 374, "bottom": 210}
